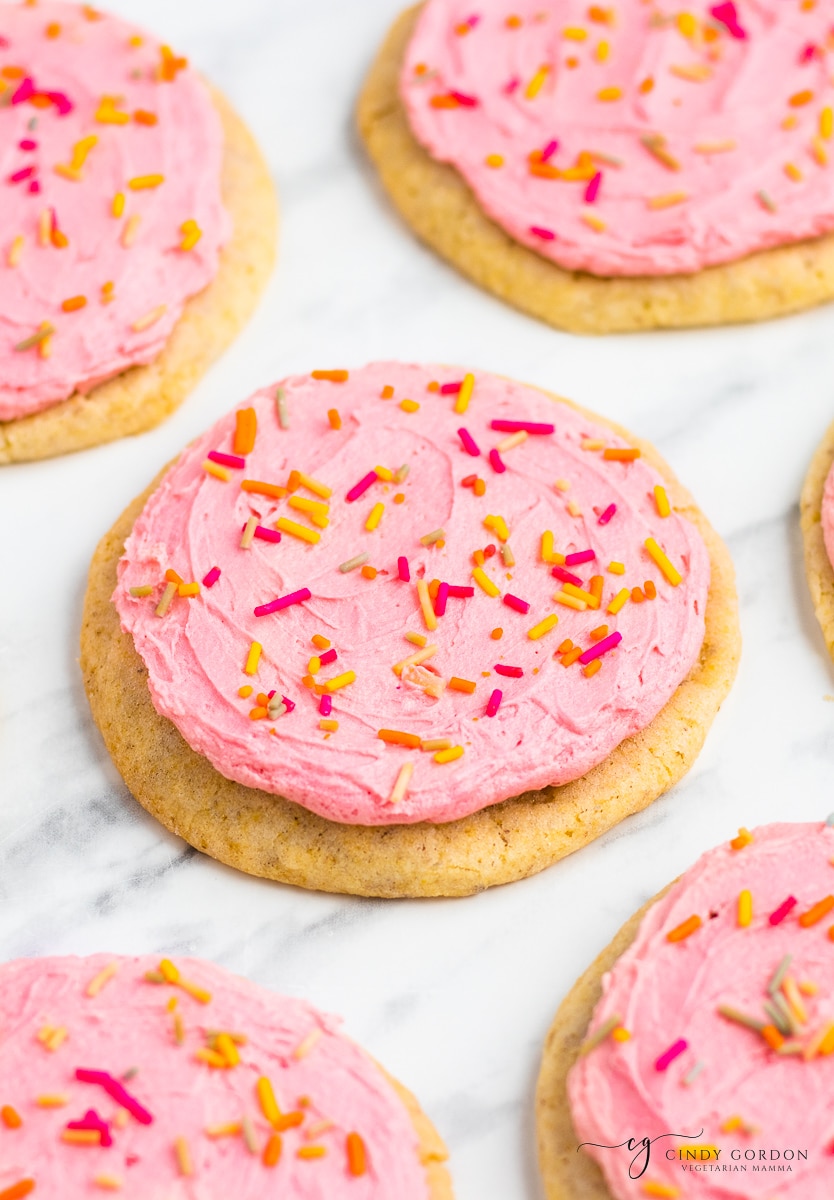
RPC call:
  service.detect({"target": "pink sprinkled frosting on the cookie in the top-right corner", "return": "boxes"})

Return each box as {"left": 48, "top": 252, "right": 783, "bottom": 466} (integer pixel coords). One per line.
{"left": 401, "top": 0, "right": 834, "bottom": 275}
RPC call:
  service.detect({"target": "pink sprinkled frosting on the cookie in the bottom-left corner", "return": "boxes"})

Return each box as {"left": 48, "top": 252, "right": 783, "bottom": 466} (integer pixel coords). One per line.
{"left": 0, "top": 955, "right": 428, "bottom": 1200}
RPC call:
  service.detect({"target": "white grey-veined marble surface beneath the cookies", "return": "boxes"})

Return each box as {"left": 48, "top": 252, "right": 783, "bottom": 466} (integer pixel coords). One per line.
{"left": 0, "top": 0, "right": 834, "bottom": 1200}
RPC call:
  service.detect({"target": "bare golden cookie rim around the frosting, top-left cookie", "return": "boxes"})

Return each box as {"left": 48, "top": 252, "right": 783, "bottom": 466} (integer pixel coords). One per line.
{"left": 0, "top": 9, "right": 277, "bottom": 464}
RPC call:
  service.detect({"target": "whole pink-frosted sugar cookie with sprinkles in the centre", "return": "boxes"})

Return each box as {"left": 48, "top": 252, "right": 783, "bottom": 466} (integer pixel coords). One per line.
{"left": 82, "top": 362, "right": 738, "bottom": 895}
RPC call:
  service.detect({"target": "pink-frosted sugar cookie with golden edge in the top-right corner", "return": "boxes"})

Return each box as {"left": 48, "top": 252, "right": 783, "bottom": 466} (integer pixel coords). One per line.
{"left": 359, "top": 0, "right": 834, "bottom": 332}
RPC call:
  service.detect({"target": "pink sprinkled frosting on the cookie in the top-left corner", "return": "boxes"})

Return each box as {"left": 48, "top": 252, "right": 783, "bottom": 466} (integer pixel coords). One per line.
{"left": 0, "top": 2, "right": 229, "bottom": 420}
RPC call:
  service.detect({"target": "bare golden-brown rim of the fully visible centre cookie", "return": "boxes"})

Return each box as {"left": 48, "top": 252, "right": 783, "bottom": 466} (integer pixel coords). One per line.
{"left": 82, "top": 377, "right": 739, "bottom": 896}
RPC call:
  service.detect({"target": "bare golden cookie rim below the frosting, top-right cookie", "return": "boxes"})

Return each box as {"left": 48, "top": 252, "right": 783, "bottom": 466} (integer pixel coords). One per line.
{"left": 358, "top": 6, "right": 834, "bottom": 334}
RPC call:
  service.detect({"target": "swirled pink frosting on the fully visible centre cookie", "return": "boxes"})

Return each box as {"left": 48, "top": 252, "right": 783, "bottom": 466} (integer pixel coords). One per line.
{"left": 114, "top": 362, "right": 709, "bottom": 824}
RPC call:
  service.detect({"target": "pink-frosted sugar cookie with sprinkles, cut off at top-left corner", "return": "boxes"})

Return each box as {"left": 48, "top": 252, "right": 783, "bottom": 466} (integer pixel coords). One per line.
{"left": 0, "top": 2, "right": 276, "bottom": 463}
